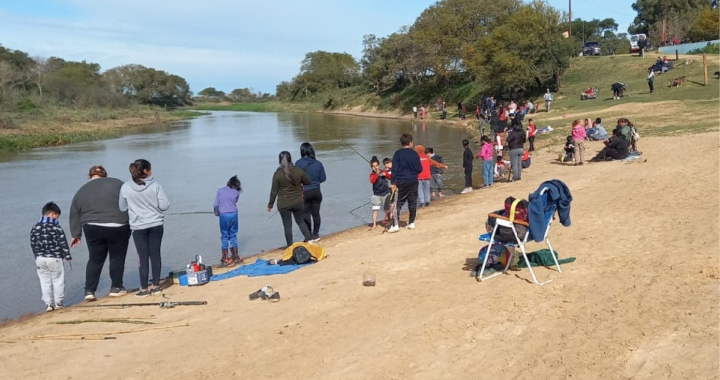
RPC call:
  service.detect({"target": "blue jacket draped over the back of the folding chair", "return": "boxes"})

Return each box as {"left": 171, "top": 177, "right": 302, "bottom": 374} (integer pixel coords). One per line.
{"left": 528, "top": 179, "right": 572, "bottom": 242}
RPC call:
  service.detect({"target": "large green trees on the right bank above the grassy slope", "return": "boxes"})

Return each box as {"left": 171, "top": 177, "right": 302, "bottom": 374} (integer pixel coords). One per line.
{"left": 275, "top": 0, "right": 718, "bottom": 104}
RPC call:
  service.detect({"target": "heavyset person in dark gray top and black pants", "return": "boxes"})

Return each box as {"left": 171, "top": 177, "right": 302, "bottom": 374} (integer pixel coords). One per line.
{"left": 70, "top": 165, "right": 130, "bottom": 301}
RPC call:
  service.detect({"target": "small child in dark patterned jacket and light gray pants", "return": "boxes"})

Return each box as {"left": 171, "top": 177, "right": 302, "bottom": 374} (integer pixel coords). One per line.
{"left": 30, "top": 202, "right": 72, "bottom": 311}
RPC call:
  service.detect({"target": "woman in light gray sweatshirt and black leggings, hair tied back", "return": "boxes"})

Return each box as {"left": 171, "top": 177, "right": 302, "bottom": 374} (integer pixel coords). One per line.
{"left": 119, "top": 159, "right": 170, "bottom": 297}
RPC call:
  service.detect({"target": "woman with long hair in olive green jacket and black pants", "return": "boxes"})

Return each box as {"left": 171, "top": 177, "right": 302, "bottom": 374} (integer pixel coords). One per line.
{"left": 267, "top": 151, "right": 312, "bottom": 247}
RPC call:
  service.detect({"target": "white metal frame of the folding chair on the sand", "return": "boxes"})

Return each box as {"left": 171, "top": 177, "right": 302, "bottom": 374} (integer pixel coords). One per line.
{"left": 477, "top": 187, "right": 562, "bottom": 285}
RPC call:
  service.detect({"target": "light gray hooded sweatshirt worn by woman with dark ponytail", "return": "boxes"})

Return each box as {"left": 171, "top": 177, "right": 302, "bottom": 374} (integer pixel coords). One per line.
{"left": 119, "top": 177, "right": 170, "bottom": 231}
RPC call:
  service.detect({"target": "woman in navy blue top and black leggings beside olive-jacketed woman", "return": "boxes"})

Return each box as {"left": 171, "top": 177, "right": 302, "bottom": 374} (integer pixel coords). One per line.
{"left": 295, "top": 142, "right": 327, "bottom": 243}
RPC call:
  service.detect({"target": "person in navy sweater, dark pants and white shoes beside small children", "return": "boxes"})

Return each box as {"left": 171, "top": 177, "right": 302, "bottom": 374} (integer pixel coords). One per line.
{"left": 388, "top": 133, "right": 422, "bottom": 233}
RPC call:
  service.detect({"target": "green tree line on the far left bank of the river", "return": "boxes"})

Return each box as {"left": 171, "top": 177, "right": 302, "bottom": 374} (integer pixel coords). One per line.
{"left": 0, "top": 45, "right": 192, "bottom": 112}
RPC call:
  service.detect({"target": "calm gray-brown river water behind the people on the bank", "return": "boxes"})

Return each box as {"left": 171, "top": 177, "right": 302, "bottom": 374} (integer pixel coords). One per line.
{"left": 0, "top": 112, "right": 476, "bottom": 319}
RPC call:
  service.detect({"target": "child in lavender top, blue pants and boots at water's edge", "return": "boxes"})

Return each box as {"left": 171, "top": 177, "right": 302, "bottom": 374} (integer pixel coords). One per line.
{"left": 213, "top": 176, "right": 242, "bottom": 268}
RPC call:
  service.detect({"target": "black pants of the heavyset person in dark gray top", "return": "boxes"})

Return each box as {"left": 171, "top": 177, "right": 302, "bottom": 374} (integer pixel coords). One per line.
{"left": 83, "top": 224, "right": 130, "bottom": 293}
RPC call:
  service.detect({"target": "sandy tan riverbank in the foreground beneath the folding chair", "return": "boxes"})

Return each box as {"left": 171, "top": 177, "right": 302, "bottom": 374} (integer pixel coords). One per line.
{"left": 0, "top": 132, "right": 720, "bottom": 380}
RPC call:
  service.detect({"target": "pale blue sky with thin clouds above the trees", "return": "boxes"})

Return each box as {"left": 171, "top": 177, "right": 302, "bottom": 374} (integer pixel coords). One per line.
{"left": 0, "top": 0, "right": 635, "bottom": 94}
